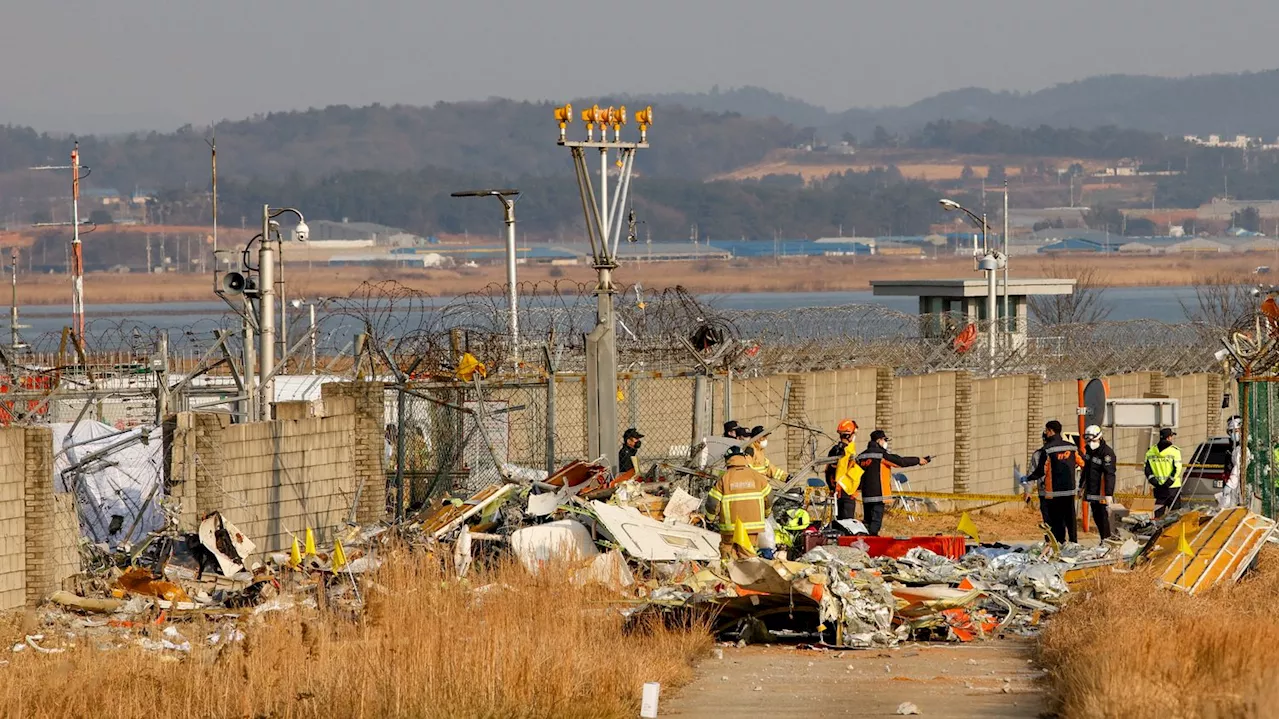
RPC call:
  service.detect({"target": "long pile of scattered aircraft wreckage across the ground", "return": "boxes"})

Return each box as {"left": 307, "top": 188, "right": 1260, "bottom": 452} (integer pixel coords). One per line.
{"left": 22, "top": 462, "right": 1276, "bottom": 654}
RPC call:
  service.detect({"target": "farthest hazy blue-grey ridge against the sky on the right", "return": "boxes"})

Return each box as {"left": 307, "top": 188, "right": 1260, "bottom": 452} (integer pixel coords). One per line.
{"left": 640, "top": 70, "right": 1280, "bottom": 141}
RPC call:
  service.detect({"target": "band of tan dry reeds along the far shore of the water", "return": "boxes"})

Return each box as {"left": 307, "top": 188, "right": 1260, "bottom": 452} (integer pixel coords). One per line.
{"left": 10, "top": 253, "right": 1274, "bottom": 307}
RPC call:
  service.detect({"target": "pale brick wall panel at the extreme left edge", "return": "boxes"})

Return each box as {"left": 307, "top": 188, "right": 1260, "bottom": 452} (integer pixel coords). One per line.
{"left": 0, "top": 427, "right": 27, "bottom": 610}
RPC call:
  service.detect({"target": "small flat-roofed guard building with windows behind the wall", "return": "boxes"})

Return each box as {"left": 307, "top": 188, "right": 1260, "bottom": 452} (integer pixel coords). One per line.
{"left": 872, "top": 279, "right": 1075, "bottom": 351}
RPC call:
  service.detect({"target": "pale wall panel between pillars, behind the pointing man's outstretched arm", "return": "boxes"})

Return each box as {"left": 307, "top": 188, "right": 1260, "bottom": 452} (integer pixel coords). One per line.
{"left": 896, "top": 372, "right": 956, "bottom": 491}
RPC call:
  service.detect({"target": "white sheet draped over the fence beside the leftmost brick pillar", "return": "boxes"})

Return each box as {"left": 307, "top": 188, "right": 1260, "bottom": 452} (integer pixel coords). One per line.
{"left": 51, "top": 420, "right": 164, "bottom": 545}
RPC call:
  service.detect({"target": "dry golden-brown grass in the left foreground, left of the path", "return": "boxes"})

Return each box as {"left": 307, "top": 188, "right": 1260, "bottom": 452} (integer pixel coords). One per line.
{"left": 0, "top": 547, "right": 710, "bottom": 719}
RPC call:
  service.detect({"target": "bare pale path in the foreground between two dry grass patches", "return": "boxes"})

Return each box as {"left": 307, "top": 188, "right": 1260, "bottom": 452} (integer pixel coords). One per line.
{"left": 659, "top": 640, "right": 1044, "bottom": 719}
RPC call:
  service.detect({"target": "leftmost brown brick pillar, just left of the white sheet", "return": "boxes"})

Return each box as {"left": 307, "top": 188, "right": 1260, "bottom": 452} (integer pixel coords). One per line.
{"left": 23, "top": 427, "right": 58, "bottom": 606}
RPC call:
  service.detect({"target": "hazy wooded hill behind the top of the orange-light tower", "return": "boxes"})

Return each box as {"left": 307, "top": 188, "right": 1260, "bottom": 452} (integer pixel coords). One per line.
{"left": 0, "top": 100, "right": 799, "bottom": 189}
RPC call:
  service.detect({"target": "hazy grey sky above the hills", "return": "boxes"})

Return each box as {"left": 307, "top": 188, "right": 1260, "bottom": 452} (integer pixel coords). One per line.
{"left": 0, "top": 0, "right": 1280, "bottom": 132}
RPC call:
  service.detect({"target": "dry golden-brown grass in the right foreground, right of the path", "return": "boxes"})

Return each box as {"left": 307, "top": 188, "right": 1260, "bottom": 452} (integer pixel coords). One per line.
{"left": 1039, "top": 546, "right": 1280, "bottom": 719}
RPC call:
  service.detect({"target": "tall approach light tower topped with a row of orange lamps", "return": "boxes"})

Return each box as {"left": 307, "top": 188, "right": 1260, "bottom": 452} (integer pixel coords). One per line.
{"left": 556, "top": 105, "right": 653, "bottom": 471}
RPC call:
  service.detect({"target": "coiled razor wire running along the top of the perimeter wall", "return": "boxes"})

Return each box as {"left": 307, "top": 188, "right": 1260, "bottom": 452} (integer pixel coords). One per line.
{"left": 5, "top": 280, "right": 1228, "bottom": 379}
